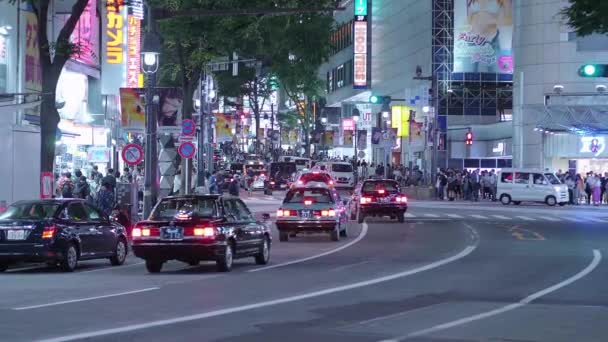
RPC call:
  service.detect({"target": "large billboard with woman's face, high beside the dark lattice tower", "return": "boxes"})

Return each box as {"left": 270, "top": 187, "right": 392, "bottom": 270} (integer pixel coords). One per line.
{"left": 453, "top": 0, "right": 513, "bottom": 74}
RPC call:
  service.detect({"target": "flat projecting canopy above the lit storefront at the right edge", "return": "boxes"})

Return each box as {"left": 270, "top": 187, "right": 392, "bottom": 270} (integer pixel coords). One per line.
{"left": 524, "top": 105, "right": 608, "bottom": 135}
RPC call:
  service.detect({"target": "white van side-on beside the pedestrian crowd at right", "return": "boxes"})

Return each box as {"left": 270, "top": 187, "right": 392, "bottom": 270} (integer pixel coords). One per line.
{"left": 496, "top": 169, "right": 569, "bottom": 206}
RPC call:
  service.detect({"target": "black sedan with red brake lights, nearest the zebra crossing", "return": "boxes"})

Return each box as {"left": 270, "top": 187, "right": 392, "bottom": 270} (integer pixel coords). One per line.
{"left": 351, "top": 179, "right": 407, "bottom": 223}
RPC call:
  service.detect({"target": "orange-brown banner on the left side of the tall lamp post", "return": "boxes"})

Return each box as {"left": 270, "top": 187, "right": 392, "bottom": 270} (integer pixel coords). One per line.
{"left": 120, "top": 88, "right": 146, "bottom": 132}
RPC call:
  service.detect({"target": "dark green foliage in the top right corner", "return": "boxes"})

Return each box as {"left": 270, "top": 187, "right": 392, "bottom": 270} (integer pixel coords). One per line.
{"left": 561, "top": 0, "right": 608, "bottom": 36}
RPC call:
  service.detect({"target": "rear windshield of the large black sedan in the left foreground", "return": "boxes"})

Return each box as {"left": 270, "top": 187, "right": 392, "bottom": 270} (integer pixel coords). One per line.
{"left": 150, "top": 198, "right": 217, "bottom": 220}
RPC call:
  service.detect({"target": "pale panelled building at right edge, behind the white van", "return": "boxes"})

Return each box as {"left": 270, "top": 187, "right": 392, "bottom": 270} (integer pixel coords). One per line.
{"left": 513, "top": 0, "right": 608, "bottom": 174}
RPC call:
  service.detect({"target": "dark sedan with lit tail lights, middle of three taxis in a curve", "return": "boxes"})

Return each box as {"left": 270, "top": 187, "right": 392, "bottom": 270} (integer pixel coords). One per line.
{"left": 276, "top": 186, "right": 349, "bottom": 241}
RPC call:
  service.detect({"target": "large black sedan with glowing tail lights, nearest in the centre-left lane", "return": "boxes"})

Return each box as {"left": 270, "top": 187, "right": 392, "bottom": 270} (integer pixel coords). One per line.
{"left": 132, "top": 195, "right": 272, "bottom": 273}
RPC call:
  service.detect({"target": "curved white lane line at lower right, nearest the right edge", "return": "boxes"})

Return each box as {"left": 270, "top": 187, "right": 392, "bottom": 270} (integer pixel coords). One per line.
{"left": 385, "top": 249, "right": 602, "bottom": 341}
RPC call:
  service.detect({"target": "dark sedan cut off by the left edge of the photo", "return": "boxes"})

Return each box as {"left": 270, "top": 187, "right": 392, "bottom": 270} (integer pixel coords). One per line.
{"left": 0, "top": 199, "right": 128, "bottom": 272}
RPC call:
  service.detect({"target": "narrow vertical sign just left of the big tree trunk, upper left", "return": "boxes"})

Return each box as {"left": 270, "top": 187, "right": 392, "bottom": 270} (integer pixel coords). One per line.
{"left": 25, "top": 12, "right": 42, "bottom": 91}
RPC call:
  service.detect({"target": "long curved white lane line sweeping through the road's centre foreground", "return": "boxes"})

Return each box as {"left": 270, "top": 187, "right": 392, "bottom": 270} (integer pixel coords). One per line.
{"left": 39, "top": 244, "right": 477, "bottom": 342}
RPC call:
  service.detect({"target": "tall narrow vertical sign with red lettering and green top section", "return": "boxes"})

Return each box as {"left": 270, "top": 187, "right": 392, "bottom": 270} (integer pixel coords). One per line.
{"left": 353, "top": 0, "right": 368, "bottom": 89}
